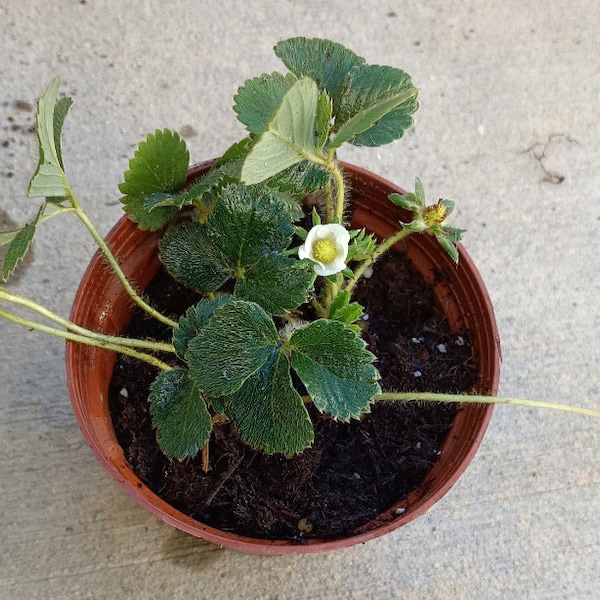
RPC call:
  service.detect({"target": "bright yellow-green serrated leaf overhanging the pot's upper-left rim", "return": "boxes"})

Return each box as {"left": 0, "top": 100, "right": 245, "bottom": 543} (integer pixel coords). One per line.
{"left": 119, "top": 129, "right": 190, "bottom": 231}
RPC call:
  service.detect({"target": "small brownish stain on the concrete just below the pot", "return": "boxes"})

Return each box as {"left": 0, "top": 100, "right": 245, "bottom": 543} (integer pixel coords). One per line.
{"left": 160, "top": 528, "right": 224, "bottom": 573}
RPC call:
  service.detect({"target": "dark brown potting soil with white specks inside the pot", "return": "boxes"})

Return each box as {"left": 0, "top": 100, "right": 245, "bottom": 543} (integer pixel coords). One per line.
{"left": 110, "top": 252, "right": 477, "bottom": 543}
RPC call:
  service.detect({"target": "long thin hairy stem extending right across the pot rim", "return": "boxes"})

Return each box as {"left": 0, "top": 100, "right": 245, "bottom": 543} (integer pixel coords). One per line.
{"left": 374, "top": 392, "right": 600, "bottom": 419}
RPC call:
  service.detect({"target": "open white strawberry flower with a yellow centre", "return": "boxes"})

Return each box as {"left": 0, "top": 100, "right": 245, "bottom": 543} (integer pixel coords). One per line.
{"left": 298, "top": 223, "right": 350, "bottom": 276}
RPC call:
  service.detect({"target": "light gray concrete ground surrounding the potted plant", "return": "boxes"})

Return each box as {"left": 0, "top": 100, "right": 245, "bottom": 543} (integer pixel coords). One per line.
{"left": 0, "top": 0, "right": 600, "bottom": 600}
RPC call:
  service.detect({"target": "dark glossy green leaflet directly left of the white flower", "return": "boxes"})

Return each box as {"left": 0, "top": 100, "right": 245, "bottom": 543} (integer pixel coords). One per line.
{"left": 207, "top": 184, "right": 294, "bottom": 268}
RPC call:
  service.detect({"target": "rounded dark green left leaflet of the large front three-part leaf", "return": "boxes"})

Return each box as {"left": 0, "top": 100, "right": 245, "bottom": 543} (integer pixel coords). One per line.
{"left": 186, "top": 300, "right": 278, "bottom": 398}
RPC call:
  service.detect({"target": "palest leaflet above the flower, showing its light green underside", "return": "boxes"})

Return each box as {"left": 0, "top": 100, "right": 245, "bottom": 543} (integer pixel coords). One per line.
{"left": 241, "top": 78, "right": 319, "bottom": 185}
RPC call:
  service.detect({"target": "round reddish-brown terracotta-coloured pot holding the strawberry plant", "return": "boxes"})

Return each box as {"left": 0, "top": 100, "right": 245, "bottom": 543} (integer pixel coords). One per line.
{"left": 66, "top": 163, "right": 500, "bottom": 554}
